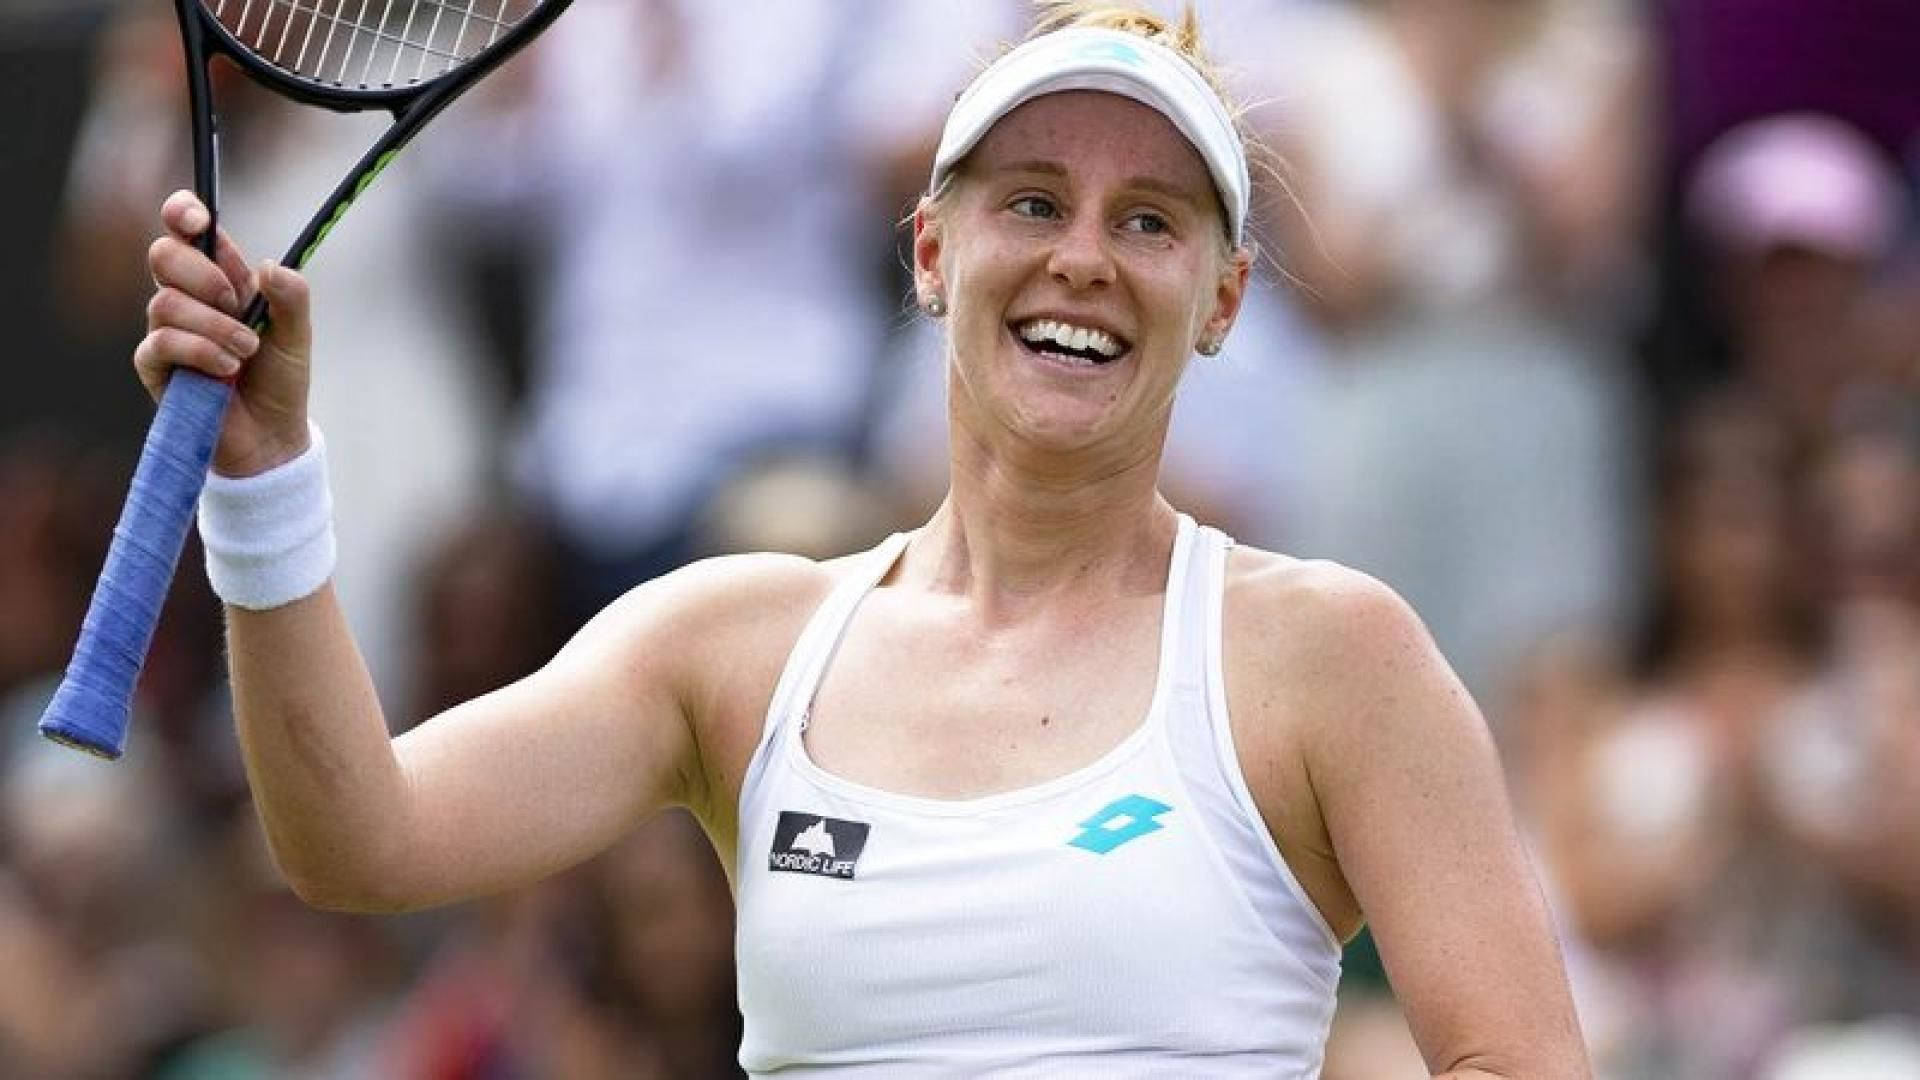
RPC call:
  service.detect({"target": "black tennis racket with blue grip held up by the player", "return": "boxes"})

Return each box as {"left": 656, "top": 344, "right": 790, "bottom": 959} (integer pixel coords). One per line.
{"left": 40, "top": 0, "right": 572, "bottom": 759}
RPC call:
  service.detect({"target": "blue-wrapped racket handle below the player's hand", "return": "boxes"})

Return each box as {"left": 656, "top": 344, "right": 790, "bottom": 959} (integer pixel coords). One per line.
{"left": 40, "top": 369, "right": 232, "bottom": 759}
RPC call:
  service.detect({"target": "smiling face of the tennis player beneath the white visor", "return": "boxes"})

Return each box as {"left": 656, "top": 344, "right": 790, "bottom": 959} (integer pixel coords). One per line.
{"left": 914, "top": 92, "right": 1248, "bottom": 454}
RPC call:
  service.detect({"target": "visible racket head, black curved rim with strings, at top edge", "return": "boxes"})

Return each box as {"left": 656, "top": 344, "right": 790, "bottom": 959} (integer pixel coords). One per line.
{"left": 190, "top": 0, "right": 570, "bottom": 111}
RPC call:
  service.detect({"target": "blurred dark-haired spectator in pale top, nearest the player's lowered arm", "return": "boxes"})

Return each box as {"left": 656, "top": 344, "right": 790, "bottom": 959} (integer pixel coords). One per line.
{"left": 1530, "top": 390, "right": 1818, "bottom": 1076}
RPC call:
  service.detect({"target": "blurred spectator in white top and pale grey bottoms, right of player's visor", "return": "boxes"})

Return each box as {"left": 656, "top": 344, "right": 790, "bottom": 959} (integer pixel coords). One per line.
{"left": 1273, "top": 0, "right": 1645, "bottom": 699}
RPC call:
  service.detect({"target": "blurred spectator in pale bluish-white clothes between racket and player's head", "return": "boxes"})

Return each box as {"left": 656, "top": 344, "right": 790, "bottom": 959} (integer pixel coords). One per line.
{"left": 433, "top": 0, "right": 1000, "bottom": 623}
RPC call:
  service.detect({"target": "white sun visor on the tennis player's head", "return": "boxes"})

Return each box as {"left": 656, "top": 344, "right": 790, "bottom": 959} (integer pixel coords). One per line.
{"left": 931, "top": 27, "right": 1250, "bottom": 244}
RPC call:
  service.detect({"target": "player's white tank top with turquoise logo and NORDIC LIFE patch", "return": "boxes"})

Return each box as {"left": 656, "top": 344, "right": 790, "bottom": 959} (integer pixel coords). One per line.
{"left": 735, "top": 515, "right": 1340, "bottom": 1080}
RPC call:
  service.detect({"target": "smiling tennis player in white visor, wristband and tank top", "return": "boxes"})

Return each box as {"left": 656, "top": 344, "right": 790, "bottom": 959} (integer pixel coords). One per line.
{"left": 136, "top": 4, "right": 1588, "bottom": 1080}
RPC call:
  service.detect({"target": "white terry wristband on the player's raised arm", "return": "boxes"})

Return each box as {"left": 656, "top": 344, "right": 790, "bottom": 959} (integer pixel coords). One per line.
{"left": 200, "top": 421, "right": 334, "bottom": 611}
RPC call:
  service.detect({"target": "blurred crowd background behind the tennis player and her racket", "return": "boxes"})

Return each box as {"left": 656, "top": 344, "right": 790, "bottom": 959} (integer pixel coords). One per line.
{"left": 0, "top": 0, "right": 1920, "bottom": 1080}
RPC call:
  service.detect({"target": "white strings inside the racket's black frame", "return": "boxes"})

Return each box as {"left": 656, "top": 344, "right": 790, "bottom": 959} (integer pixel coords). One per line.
{"left": 202, "top": 0, "right": 538, "bottom": 90}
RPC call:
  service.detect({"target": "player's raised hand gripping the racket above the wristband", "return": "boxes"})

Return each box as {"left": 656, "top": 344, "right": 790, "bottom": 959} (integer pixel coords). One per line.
{"left": 132, "top": 190, "right": 313, "bottom": 477}
